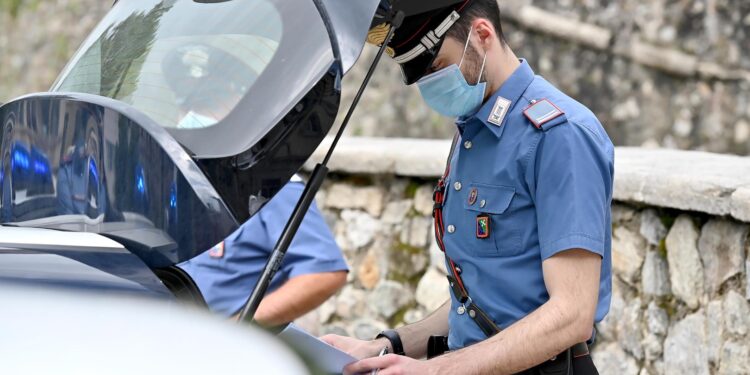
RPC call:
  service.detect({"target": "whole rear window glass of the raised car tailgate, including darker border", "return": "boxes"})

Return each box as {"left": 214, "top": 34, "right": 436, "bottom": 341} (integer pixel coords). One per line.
{"left": 51, "top": 0, "right": 334, "bottom": 157}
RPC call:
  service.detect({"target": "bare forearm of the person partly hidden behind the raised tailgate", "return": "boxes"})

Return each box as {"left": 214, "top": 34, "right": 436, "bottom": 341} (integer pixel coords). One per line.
{"left": 245, "top": 271, "right": 346, "bottom": 327}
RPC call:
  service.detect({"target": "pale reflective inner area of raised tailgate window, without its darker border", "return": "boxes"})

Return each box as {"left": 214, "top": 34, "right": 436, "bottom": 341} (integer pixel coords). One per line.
{"left": 53, "top": 0, "right": 283, "bottom": 129}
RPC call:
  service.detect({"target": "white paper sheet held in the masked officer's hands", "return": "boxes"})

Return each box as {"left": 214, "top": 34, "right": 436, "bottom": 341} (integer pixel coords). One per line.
{"left": 279, "top": 323, "right": 357, "bottom": 374}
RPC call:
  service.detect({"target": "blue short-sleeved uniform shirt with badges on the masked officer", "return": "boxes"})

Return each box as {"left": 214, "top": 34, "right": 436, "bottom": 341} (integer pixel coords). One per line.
{"left": 443, "top": 60, "right": 614, "bottom": 350}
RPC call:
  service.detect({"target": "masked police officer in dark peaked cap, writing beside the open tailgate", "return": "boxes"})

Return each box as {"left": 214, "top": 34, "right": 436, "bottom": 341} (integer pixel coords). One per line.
{"left": 323, "top": 0, "right": 614, "bottom": 375}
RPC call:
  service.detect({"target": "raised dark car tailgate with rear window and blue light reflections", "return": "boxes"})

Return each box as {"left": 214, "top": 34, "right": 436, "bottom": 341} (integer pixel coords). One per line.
{"left": 0, "top": 0, "right": 380, "bottom": 268}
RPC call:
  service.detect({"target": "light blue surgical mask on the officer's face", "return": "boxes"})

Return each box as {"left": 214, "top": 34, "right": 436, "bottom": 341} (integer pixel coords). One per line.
{"left": 417, "top": 30, "right": 487, "bottom": 117}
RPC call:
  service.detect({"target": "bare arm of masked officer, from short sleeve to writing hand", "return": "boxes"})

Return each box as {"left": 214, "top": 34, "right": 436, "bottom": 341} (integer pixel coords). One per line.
{"left": 433, "top": 249, "right": 601, "bottom": 374}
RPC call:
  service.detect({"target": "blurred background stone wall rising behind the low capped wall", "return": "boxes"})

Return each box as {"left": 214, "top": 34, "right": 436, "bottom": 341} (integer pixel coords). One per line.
{"left": 0, "top": 0, "right": 750, "bottom": 154}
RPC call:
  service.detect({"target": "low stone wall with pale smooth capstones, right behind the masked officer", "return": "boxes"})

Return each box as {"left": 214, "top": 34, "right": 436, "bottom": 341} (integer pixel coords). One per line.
{"left": 300, "top": 138, "right": 750, "bottom": 375}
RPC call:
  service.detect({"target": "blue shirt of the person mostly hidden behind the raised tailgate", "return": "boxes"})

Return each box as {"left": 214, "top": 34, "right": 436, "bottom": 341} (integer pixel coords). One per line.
{"left": 179, "top": 182, "right": 348, "bottom": 316}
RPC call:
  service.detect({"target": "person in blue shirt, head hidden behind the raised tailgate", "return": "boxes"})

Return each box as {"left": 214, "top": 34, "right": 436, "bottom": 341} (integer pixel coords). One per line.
{"left": 179, "top": 176, "right": 348, "bottom": 327}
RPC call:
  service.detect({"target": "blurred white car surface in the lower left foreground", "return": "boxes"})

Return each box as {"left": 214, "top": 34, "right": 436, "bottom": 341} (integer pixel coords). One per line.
{"left": 0, "top": 284, "right": 309, "bottom": 375}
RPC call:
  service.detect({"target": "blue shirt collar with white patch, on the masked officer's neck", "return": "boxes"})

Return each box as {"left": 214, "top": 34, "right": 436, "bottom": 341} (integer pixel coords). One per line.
{"left": 457, "top": 59, "right": 534, "bottom": 138}
